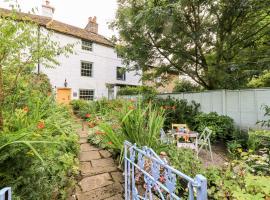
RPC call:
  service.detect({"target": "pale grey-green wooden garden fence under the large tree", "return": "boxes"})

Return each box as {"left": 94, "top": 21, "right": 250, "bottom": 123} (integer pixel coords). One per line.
{"left": 120, "top": 88, "right": 270, "bottom": 129}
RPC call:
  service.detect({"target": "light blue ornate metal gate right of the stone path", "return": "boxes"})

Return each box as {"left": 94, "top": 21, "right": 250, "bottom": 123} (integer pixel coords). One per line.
{"left": 124, "top": 141, "right": 207, "bottom": 200}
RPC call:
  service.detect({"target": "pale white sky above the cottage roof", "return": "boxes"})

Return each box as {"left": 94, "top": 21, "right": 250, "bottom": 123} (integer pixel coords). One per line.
{"left": 0, "top": 0, "right": 117, "bottom": 38}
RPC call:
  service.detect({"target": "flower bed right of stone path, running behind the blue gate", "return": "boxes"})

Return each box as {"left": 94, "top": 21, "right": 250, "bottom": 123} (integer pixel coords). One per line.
{"left": 71, "top": 100, "right": 270, "bottom": 200}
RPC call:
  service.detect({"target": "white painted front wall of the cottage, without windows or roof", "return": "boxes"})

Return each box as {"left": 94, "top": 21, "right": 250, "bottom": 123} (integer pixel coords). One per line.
{"left": 41, "top": 30, "right": 141, "bottom": 99}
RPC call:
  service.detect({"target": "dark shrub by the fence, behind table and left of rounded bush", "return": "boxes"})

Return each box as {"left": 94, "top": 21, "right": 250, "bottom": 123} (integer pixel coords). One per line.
{"left": 152, "top": 98, "right": 200, "bottom": 130}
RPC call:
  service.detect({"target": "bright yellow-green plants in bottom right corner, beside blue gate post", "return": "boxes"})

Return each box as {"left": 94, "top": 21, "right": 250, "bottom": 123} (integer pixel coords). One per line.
{"left": 205, "top": 163, "right": 270, "bottom": 200}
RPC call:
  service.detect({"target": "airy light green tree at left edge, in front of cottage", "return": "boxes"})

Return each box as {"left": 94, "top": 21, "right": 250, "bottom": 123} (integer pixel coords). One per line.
{"left": 0, "top": 6, "right": 73, "bottom": 131}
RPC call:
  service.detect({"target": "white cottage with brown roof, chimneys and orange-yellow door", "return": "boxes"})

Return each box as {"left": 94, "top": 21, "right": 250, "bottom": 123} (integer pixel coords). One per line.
{"left": 1, "top": 1, "right": 141, "bottom": 103}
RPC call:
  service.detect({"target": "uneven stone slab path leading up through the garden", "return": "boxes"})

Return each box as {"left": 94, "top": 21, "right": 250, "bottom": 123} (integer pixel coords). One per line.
{"left": 75, "top": 122, "right": 124, "bottom": 200}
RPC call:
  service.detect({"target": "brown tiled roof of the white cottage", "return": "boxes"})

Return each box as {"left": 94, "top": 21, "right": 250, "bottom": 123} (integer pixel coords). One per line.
{"left": 0, "top": 8, "right": 114, "bottom": 47}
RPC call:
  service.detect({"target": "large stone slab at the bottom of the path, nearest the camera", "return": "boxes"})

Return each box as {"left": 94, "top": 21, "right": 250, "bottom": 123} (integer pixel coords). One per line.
{"left": 77, "top": 183, "right": 123, "bottom": 200}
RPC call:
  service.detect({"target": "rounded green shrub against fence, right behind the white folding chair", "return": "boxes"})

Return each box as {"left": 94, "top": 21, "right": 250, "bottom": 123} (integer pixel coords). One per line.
{"left": 194, "top": 112, "right": 235, "bottom": 142}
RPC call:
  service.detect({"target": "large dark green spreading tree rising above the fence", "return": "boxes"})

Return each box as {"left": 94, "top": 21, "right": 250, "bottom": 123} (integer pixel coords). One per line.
{"left": 112, "top": 0, "right": 270, "bottom": 89}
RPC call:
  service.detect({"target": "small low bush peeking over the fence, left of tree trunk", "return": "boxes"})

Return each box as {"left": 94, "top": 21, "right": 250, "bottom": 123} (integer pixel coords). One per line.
{"left": 173, "top": 79, "right": 202, "bottom": 92}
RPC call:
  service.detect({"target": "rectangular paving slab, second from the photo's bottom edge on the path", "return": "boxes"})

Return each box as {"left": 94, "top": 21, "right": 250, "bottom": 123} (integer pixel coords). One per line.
{"left": 79, "top": 173, "right": 113, "bottom": 192}
